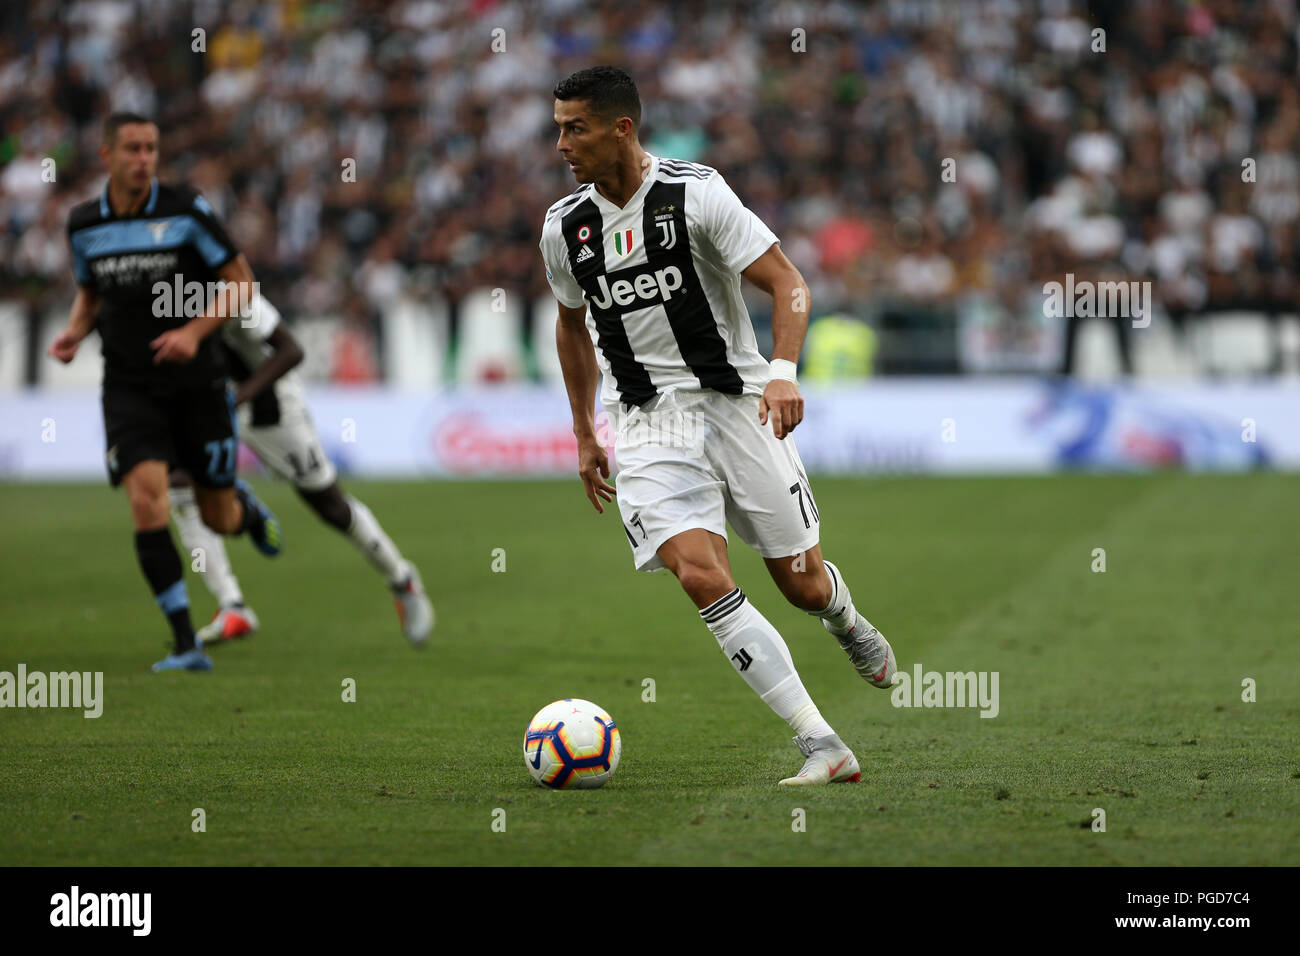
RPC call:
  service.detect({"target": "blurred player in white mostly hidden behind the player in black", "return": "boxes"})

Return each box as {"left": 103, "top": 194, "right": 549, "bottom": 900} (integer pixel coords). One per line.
{"left": 172, "top": 295, "right": 434, "bottom": 648}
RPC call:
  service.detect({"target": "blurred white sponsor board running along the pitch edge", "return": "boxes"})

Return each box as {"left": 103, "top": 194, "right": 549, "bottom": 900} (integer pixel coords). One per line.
{"left": 0, "top": 378, "right": 1300, "bottom": 480}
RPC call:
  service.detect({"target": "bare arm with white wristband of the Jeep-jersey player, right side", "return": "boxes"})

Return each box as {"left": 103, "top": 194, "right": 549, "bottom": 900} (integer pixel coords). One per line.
{"left": 741, "top": 243, "right": 810, "bottom": 438}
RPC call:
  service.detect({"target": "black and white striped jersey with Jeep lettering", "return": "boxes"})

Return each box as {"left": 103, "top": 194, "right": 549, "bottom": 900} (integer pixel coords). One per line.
{"left": 541, "top": 156, "right": 777, "bottom": 405}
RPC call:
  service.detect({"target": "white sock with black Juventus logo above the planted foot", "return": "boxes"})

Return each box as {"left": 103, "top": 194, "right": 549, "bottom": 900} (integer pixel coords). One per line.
{"left": 699, "top": 588, "right": 835, "bottom": 737}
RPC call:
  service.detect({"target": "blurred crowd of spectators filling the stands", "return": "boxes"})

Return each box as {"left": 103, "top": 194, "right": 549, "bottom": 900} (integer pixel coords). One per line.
{"left": 0, "top": 0, "right": 1300, "bottom": 378}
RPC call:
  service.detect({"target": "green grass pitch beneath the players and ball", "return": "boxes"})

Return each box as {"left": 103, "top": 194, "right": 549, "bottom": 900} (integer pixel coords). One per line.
{"left": 0, "top": 473, "right": 1300, "bottom": 865}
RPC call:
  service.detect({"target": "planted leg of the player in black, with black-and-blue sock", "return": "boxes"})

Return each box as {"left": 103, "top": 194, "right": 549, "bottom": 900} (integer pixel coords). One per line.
{"left": 120, "top": 463, "right": 212, "bottom": 671}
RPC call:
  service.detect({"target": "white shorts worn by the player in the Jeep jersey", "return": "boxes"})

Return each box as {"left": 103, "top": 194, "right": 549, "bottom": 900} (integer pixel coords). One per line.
{"left": 610, "top": 389, "right": 819, "bottom": 571}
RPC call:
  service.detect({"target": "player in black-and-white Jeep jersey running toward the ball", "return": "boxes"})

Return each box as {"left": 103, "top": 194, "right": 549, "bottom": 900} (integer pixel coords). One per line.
{"left": 541, "top": 66, "right": 896, "bottom": 786}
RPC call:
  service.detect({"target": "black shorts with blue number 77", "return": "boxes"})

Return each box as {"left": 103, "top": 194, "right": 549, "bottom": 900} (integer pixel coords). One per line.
{"left": 100, "top": 382, "right": 239, "bottom": 488}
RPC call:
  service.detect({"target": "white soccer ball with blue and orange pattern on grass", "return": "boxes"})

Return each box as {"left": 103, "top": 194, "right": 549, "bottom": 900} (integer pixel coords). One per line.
{"left": 524, "top": 697, "right": 623, "bottom": 790}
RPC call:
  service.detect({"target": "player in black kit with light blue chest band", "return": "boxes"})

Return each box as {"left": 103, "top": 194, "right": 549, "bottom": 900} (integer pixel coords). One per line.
{"left": 49, "top": 113, "right": 281, "bottom": 671}
